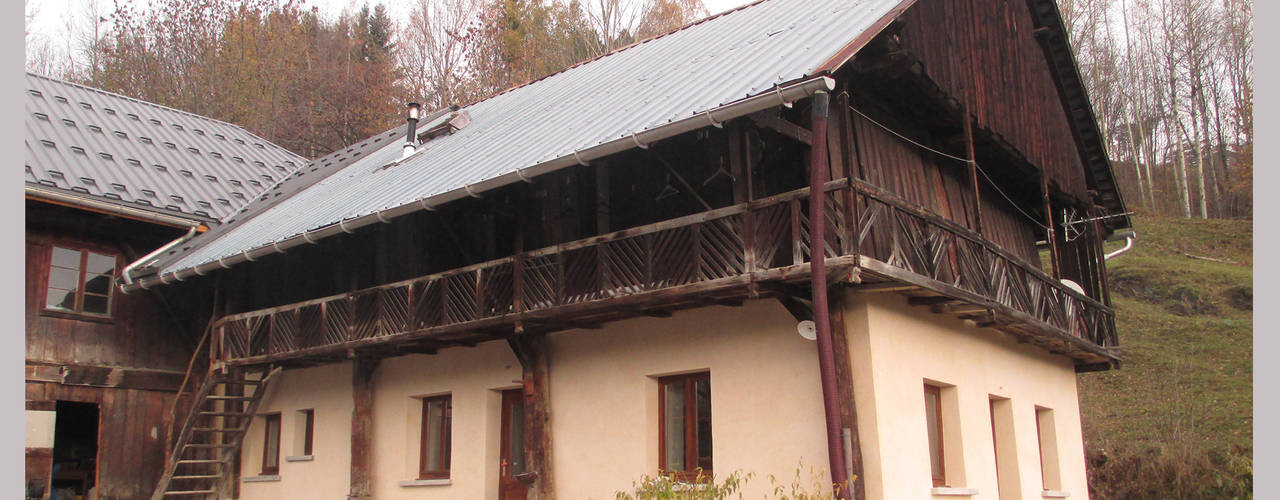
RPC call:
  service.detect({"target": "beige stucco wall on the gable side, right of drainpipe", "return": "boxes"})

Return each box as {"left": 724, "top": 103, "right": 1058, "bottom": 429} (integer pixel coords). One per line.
{"left": 846, "top": 293, "right": 1088, "bottom": 499}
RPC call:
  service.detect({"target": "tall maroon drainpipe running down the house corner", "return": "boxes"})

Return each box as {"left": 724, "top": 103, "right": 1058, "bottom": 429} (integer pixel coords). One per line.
{"left": 809, "top": 91, "right": 851, "bottom": 500}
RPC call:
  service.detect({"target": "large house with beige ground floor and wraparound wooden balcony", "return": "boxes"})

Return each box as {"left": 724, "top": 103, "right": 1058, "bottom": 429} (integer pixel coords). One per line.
{"left": 124, "top": 0, "right": 1129, "bottom": 500}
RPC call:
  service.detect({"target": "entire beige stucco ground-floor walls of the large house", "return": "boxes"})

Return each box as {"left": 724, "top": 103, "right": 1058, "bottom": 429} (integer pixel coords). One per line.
{"left": 232, "top": 293, "right": 1087, "bottom": 500}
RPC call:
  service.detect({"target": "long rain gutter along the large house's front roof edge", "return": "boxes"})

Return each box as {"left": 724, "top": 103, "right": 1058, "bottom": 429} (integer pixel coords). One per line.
{"left": 122, "top": 73, "right": 836, "bottom": 292}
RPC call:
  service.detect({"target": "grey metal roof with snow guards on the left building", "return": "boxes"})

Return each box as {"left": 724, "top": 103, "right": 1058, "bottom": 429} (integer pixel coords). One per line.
{"left": 23, "top": 73, "right": 306, "bottom": 221}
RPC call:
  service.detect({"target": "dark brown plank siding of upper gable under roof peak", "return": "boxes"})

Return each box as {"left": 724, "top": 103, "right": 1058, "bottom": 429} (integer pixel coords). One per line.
{"left": 900, "top": 0, "right": 1089, "bottom": 201}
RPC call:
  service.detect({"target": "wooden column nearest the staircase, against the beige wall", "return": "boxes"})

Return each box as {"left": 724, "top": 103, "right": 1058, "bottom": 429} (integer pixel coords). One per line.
{"left": 347, "top": 358, "right": 379, "bottom": 500}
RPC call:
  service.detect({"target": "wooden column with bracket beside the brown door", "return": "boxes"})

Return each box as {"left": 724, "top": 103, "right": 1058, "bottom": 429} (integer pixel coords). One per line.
{"left": 507, "top": 334, "right": 556, "bottom": 500}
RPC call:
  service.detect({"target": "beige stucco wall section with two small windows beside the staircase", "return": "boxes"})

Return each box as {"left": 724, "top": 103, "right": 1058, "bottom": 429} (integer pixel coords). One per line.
{"left": 241, "top": 362, "right": 353, "bottom": 500}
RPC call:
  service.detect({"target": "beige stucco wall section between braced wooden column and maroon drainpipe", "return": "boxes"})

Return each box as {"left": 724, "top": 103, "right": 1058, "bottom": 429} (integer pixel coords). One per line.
{"left": 550, "top": 299, "right": 829, "bottom": 500}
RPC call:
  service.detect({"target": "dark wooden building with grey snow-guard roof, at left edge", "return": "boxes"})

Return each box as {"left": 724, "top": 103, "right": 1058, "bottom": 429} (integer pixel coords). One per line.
{"left": 22, "top": 73, "right": 306, "bottom": 499}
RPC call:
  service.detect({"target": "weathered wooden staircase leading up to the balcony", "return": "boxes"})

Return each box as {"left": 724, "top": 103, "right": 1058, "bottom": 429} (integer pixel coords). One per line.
{"left": 151, "top": 368, "right": 280, "bottom": 500}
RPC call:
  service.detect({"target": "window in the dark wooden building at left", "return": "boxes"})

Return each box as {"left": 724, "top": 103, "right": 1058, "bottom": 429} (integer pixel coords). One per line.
{"left": 45, "top": 247, "right": 115, "bottom": 317}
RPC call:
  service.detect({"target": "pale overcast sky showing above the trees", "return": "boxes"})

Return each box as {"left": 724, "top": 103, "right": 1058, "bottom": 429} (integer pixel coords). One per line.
{"left": 27, "top": 0, "right": 750, "bottom": 54}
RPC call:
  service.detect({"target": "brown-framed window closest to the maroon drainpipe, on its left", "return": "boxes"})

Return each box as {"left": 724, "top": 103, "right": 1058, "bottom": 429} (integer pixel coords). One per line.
{"left": 658, "top": 372, "right": 712, "bottom": 480}
